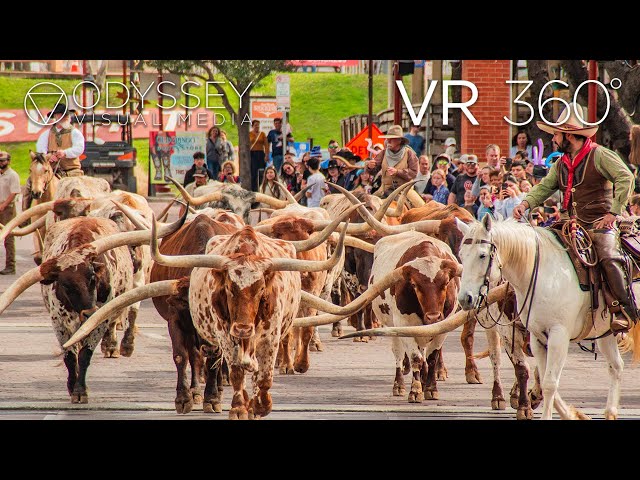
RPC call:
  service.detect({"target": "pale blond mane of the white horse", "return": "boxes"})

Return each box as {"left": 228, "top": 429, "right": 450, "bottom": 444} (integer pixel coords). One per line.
{"left": 469, "top": 218, "right": 569, "bottom": 276}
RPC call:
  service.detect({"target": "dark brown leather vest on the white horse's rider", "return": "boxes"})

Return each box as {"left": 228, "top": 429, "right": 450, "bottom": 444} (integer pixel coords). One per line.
{"left": 558, "top": 147, "right": 613, "bottom": 223}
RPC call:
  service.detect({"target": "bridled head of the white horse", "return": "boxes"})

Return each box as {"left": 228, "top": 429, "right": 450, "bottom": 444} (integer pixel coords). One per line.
{"left": 456, "top": 215, "right": 502, "bottom": 310}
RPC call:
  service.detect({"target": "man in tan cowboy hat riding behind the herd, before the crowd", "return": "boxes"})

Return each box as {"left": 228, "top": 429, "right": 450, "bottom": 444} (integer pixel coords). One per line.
{"left": 367, "top": 125, "right": 418, "bottom": 198}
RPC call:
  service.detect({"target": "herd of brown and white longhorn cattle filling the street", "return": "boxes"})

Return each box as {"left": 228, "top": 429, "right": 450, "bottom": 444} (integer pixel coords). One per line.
{"left": 0, "top": 166, "right": 568, "bottom": 419}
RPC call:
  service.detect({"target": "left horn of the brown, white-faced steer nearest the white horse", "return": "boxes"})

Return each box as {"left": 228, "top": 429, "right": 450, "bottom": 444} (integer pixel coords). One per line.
{"left": 294, "top": 267, "right": 403, "bottom": 327}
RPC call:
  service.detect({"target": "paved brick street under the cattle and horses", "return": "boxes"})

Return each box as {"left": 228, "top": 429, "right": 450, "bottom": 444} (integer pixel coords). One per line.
{"left": 0, "top": 203, "right": 640, "bottom": 420}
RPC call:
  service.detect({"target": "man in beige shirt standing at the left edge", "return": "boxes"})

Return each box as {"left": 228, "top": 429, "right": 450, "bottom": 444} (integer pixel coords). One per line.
{"left": 0, "top": 151, "right": 20, "bottom": 275}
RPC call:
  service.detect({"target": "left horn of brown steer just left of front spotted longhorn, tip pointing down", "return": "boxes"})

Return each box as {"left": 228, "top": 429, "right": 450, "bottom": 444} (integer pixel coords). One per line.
{"left": 62, "top": 280, "right": 180, "bottom": 348}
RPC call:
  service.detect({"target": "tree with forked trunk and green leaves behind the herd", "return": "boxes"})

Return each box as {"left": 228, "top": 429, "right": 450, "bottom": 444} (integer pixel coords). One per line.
{"left": 146, "top": 60, "right": 292, "bottom": 190}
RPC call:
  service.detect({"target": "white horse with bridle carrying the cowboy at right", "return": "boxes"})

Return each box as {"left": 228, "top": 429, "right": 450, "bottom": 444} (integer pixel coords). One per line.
{"left": 458, "top": 215, "right": 640, "bottom": 420}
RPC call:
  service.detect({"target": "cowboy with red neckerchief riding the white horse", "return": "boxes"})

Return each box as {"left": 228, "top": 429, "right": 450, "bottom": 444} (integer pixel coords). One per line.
{"left": 513, "top": 104, "right": 638, "bottom": 333}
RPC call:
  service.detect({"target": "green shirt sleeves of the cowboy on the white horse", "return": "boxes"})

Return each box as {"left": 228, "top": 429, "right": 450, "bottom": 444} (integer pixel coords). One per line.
{"left": 524, "top": 146, "right": 634, "bottom": 215}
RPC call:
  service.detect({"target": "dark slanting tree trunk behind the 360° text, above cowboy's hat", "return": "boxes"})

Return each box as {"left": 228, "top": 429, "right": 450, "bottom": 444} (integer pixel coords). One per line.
{"left": 561, "top": 60, "right": 631, "bottom": 151}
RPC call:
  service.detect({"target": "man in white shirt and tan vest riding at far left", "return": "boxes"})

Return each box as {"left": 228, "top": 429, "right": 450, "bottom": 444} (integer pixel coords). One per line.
{"left": 27, "top": 103, "right": 84, "bottom": 210}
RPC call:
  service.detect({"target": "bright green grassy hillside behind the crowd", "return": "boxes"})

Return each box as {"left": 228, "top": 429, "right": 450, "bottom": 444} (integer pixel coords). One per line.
{"left": 0, "top": 73, "right": 387, "bottom": 182}
